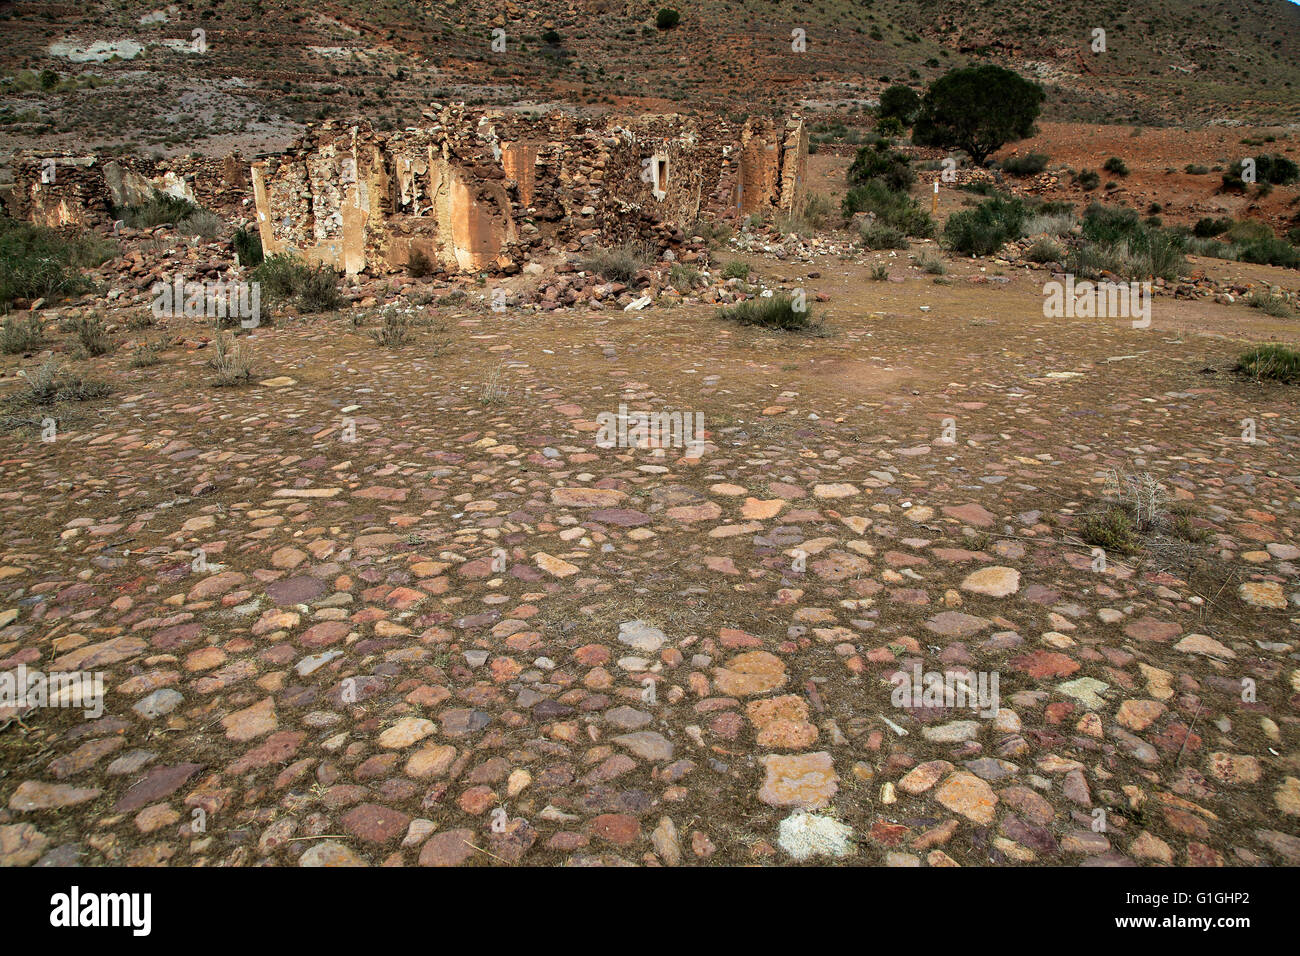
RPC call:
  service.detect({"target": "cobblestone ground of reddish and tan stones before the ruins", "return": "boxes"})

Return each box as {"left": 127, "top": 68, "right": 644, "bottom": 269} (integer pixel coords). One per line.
{"left": 0, "top": 267, "right": 1300, "bottom": 866}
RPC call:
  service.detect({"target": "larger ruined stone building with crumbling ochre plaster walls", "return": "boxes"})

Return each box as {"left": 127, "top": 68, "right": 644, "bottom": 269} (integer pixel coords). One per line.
{"left": 252, "top": 105, "right": 807, "bottom": 274}
